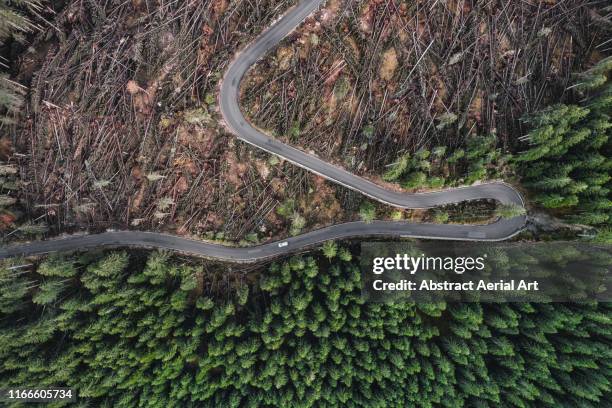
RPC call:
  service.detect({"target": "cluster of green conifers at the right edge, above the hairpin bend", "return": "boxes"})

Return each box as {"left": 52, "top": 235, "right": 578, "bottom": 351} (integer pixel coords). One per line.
{"left": 516, "top": 58, "right": 612, "bottom": 225}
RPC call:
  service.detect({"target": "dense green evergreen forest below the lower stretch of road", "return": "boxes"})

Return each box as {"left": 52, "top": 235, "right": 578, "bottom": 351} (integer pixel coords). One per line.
{"left": 0, "top": 250, "right": 612, "bottom": 408}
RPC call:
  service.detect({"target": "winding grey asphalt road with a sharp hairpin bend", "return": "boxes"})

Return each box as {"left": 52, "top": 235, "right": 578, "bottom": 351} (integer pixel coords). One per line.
{"left": 0, "top": 0, "right": 526, "bottom": 262}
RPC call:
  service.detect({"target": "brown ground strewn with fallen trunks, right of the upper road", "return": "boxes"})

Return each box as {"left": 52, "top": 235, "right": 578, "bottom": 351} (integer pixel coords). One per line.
{"left": 243, "top": 0, "right": 605, "bottom": 178}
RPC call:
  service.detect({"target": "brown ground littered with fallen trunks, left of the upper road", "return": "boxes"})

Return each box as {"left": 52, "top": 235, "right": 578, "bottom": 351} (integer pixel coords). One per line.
{"left": 15, "top": 0, "right": 358, "bottom": 242}
